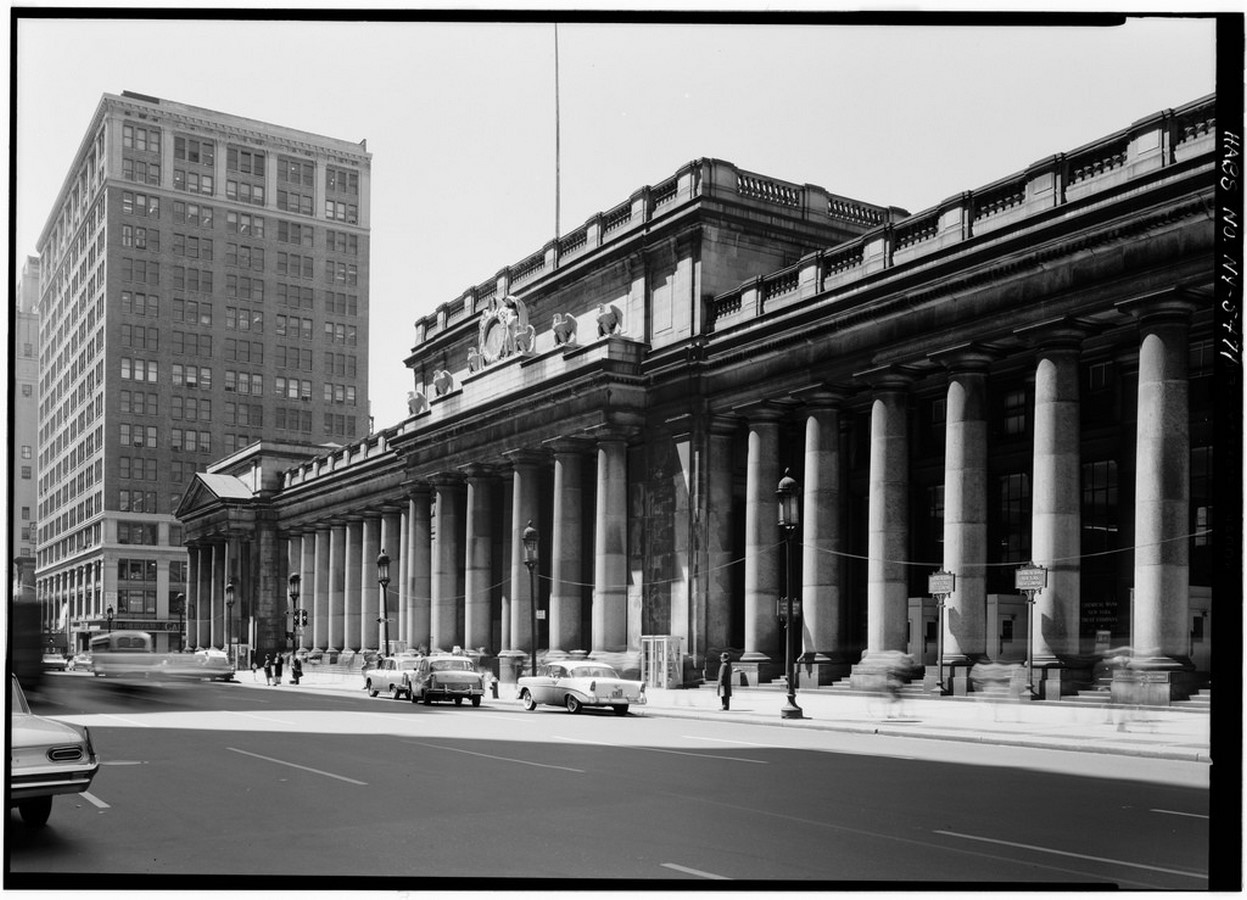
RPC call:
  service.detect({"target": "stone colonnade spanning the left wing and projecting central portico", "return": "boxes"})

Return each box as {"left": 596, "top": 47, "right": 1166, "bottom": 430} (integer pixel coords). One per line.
{"left": 266, "top": 430, "right": 628, "bottom": 654}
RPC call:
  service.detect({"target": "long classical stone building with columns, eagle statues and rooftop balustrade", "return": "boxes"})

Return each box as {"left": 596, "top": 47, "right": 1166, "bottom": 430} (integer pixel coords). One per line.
{"left": 178, "top": 97, "right": 1216, "bottom": 703}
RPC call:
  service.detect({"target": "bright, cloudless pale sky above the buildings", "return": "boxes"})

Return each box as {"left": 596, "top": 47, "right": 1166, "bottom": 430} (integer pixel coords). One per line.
{"left": 10, "top": 5, "right": 1216, "bottom": 429}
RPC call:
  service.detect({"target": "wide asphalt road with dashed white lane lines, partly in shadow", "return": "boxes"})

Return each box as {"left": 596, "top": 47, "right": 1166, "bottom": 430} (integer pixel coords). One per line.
{"left": 6, "top": 676, "right": 1210, "bottom": 890}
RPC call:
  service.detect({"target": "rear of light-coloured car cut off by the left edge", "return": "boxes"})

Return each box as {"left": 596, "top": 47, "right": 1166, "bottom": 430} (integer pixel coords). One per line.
{"left": 9, "top": 676, "right": 100, "bottom": 825}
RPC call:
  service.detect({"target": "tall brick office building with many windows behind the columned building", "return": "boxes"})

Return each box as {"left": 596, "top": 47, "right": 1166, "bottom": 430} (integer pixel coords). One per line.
{"left": 35, "top": 91, "right": 372, "bottom": 649}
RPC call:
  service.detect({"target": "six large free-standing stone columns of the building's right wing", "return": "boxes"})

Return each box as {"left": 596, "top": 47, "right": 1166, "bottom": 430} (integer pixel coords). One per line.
{"left": 728, "top": 292, "right": 1195, "bottom": 689}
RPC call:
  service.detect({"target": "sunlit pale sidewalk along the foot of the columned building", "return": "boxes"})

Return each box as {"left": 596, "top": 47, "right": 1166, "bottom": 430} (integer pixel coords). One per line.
{"left": 236, "top": 667, "right": 1211, "bottom": 763}
